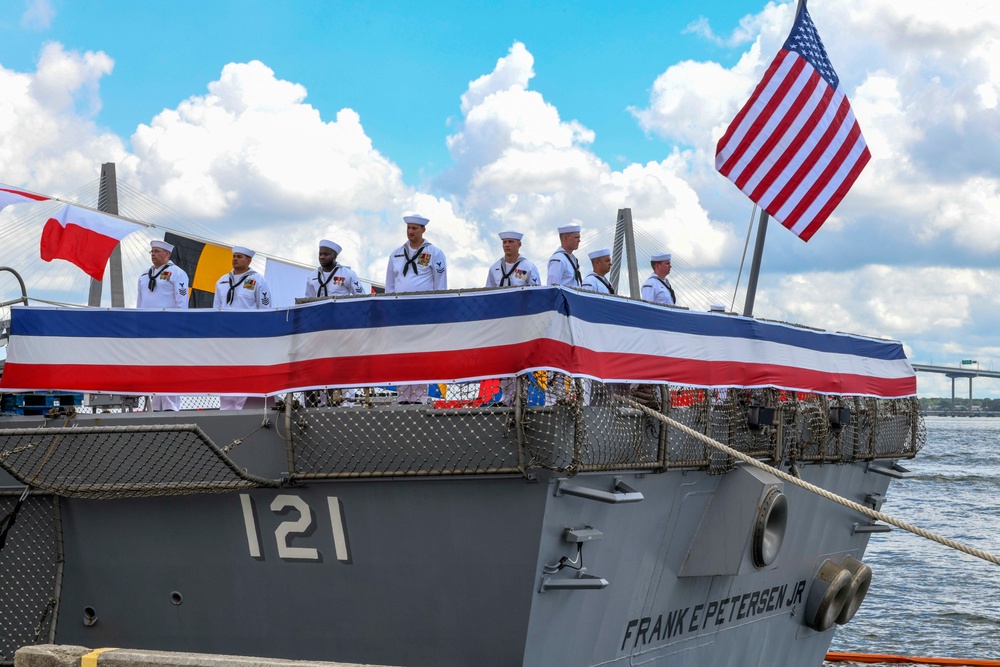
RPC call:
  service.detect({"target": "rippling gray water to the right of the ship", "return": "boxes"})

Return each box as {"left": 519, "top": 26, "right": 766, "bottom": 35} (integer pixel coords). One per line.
{"left": 831, "top": 417, "right": 1000, "bottom": 660}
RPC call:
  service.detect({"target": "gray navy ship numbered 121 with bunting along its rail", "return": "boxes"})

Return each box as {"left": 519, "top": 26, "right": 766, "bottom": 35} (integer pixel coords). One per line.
{"left": 0, "top": 258, "right": 925, "bottom": 667}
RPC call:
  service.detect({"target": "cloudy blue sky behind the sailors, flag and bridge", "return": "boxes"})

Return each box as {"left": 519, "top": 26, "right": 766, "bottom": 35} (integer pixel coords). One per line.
{"left": 0, "top": 0, "right": 1000, "bottom": 396}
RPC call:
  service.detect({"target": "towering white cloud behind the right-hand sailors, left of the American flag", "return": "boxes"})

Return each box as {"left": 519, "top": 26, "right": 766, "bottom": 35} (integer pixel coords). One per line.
{"left": 440, "top": 42, "right": 728, "bottom": 298}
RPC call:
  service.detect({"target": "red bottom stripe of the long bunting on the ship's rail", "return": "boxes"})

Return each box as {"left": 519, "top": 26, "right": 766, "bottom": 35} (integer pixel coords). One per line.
{"left": 4, "top": 339, "right": 916, "bottom": 398}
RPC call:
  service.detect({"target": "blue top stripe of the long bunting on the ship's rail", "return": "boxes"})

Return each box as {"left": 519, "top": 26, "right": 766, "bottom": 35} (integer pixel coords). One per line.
{"left": 11, "top": 287, "right": 906, "bottom": 360}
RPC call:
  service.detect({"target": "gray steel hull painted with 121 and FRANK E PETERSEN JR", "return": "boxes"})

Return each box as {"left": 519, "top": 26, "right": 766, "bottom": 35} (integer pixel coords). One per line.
{"left": 0, "top": 402, "right": 908, "bottom": 667}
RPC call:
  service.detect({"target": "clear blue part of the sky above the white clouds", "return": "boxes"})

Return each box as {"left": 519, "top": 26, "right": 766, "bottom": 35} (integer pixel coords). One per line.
{"left": 0, "top": 0, "right": 760, "bottom": 185}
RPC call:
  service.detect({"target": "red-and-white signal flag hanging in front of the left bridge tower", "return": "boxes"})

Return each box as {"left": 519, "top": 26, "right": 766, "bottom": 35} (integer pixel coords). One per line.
{"left": 41, "top": 206, "right": 142, "bottom": 280}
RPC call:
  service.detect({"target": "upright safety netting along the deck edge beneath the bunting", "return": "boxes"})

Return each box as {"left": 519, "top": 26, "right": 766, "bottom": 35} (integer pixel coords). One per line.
{"left": 284, "top": 372, "right": 926, "bottom": 477}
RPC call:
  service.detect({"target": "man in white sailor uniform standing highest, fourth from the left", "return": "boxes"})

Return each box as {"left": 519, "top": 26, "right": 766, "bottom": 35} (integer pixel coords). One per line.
{"left": 385, "top": 214, "right": 448, "bottom": 403}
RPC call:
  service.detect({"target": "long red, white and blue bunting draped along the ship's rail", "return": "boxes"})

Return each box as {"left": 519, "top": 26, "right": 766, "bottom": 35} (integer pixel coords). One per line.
{"left": 0, "top": 287, "right": 916, "bottom": 398}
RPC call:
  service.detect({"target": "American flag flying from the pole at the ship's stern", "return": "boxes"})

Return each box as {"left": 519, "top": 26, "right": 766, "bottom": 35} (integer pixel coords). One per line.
{"left": 715, "top": 0, "right": 871, "bottom": 241}
